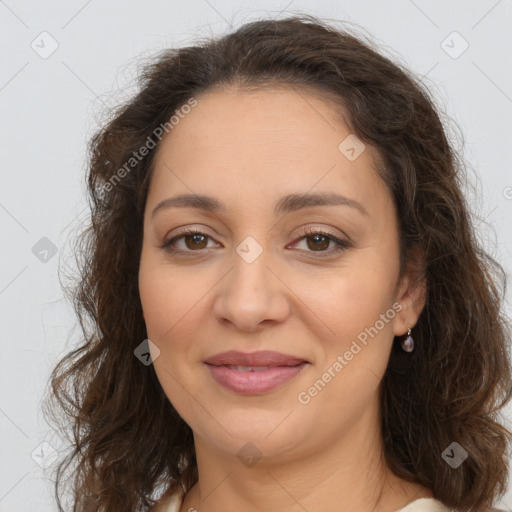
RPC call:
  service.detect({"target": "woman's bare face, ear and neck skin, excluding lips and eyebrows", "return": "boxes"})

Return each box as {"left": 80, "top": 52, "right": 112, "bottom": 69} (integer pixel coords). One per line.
{"left": 139, "top": 89, "right": 430, "bottom": 512}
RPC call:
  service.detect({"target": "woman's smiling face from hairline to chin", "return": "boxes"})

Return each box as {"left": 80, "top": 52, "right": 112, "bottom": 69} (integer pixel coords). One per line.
{"left": 139, "top": 90, "right": 417, "bottom": 461}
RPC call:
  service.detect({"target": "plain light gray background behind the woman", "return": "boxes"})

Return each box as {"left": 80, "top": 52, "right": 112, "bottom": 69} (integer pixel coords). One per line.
{"left": 0, "top": 0, "right": 512, "bottom": 512}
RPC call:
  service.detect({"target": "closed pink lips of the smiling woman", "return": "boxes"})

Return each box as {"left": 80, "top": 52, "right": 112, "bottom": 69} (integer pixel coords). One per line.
{"left": 204, "top": 350, "right": 310, "bottom": 395}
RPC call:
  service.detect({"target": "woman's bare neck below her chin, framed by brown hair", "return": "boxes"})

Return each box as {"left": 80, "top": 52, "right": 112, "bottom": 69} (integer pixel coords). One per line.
{"left": 181, "top": 402, "right": 429, "bottom": 512}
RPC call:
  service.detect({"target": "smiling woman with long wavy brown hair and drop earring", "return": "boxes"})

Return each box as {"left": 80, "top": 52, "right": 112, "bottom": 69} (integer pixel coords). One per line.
{"left": 44, "top": 16, "right": 512, "bottom": 512}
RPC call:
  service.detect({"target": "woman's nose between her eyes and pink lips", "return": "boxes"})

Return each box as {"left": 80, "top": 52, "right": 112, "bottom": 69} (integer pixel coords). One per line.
{"left": 213, "top": 245, "right": 290, "bottom": 332}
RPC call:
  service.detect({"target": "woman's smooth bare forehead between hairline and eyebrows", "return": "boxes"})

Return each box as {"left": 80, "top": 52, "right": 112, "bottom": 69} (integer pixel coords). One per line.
{"left": 146, "top": 88, "right": 389, "bottom": 218}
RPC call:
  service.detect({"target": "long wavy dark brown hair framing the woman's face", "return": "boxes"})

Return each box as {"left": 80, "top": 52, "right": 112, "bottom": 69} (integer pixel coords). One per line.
{"left": 48, "top": 15, "right": 512, "bottom": 512}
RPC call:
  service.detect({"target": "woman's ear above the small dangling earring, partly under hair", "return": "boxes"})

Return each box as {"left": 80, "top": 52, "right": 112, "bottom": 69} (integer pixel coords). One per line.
{"left": 393, "top": 246, "right": 427, "bottom": 336}
